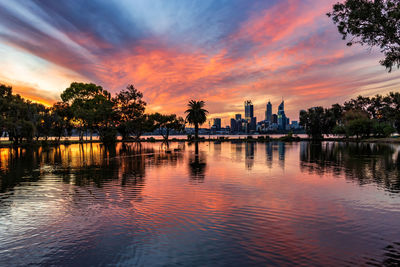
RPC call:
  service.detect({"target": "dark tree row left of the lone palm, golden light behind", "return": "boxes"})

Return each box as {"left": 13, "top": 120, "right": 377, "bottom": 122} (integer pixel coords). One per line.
{"left": 0, "top": 82, "right": 185, "bottom": 144}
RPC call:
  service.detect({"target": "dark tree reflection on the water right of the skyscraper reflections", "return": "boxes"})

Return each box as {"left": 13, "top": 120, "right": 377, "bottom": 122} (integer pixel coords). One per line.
{"left": 300, "top": 142, "right": 400, "bottom": 192}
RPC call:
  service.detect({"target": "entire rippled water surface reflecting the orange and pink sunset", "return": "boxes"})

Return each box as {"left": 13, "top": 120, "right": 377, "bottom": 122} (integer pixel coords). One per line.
{"left": 0, "top": 142, "right": 400, "bottom": 266}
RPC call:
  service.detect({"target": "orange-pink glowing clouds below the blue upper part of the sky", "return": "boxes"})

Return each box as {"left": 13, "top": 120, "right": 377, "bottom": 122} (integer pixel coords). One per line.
{"left": 1, "top": 0, "right": 400, "bottom": 123}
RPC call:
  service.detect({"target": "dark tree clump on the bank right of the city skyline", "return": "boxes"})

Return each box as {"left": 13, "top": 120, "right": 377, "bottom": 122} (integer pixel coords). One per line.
{"left": 300, "top": 92, "right": 400, "bottom": 139}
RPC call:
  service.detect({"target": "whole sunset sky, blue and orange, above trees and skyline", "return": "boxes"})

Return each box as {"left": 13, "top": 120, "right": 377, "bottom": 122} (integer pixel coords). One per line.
{"left": 0, "top": 0, "right": 400, "bottom": 124}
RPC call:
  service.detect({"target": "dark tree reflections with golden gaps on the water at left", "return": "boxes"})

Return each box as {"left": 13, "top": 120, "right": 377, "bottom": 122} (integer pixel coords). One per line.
{"left": 0, "top": 143, "right": 183, "bottom": 192}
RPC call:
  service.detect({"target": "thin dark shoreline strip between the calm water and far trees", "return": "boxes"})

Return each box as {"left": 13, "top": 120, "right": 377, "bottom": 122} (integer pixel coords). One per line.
{"left": 0, "top": 136, "right": 400, "bottom": 148}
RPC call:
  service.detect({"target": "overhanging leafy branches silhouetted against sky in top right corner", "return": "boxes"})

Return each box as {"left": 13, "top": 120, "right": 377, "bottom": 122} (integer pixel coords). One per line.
{"left": 327, "top": 0, "right": 400, "bottom": 72}
